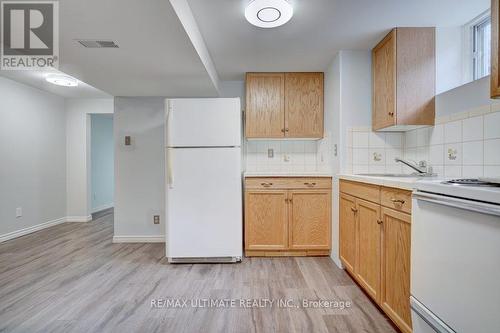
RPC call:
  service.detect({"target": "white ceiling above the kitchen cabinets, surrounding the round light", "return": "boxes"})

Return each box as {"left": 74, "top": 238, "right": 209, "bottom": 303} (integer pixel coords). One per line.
{"left": 189, "top": 0, "right": 490, "bottom": 80}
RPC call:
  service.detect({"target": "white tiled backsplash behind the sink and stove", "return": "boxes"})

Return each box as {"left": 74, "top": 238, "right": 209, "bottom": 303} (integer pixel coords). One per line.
{"left": 346, "top": 108, "right": 500, "bottom": 178}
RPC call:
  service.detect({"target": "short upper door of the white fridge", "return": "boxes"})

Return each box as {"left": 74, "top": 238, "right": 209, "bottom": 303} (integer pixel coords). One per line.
{"left": 165, "top": 98, "right": 241, "bottom": 147}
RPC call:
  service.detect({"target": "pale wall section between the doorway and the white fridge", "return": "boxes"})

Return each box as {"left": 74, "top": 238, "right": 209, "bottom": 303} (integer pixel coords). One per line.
{"left": 114, "top": 97, "right": 165, "bottom": 241}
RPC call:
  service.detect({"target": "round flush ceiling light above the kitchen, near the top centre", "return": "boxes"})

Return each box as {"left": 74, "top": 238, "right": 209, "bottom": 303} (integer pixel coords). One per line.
{"left": 245, "top": 0, "right": 293, "bottom": 28}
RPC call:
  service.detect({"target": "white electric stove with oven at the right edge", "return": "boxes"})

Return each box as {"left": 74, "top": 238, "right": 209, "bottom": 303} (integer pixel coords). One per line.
{"left": 410, "top": 180, "right": 500, "bottom": 333}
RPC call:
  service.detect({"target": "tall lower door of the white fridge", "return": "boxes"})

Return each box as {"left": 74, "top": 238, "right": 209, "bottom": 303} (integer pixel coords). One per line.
{"left": 166, "top": 148, "right": 243, "bottom": 258}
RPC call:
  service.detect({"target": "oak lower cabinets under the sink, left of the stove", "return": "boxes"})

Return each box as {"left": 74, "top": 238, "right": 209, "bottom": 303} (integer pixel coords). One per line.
{"left": 339, "top": 180, "right": 412, "bottom": 333}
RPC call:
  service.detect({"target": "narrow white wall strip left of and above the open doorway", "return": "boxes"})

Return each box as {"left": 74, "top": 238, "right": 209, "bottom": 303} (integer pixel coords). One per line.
{"left": 65, "top": 99, "right": 113, "bottom": 221}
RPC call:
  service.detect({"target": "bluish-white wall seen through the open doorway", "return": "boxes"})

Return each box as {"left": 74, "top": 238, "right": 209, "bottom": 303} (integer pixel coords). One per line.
{"left": 90, "top": 114, "right": 115, "bottom": 212}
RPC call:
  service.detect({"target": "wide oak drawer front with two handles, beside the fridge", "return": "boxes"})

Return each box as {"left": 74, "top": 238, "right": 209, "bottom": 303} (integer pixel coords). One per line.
{"left": 245, "top": 177, "right": 332, "bottom": 190}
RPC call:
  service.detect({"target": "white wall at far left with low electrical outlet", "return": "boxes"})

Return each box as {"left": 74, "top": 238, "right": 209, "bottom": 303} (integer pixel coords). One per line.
{"left": 0, "top": 77, "right": 66, "bottom": 240}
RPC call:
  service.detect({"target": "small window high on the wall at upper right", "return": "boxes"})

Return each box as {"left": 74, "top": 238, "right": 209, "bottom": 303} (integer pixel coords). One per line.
{"left": 472, "top": 17, "right": 491, "bottom": 80}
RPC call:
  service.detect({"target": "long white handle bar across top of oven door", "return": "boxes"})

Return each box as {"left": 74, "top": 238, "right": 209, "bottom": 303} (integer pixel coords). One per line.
{"left": 413, "top": 191, "right": 500, "bottom": 216}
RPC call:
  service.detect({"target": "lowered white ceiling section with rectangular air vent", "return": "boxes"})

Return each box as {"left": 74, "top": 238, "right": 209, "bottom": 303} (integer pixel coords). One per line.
{"left": 0, "top": 0, "right": 217, "bottom": 97}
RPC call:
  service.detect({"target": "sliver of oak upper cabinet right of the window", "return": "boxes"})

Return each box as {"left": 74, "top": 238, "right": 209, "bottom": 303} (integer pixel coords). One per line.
{"left": 490, "top": 0, "right": 500, "bottom": 98}
